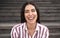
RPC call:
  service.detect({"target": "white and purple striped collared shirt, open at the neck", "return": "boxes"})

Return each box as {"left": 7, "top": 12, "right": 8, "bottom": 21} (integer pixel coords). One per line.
{"left": 11, "top": 23, "right": 49, "bottom": 38}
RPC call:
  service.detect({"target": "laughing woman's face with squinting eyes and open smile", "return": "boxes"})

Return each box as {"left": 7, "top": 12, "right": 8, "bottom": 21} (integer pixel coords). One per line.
{"left": 24, "top": 4, "right": 37, "bottom": 23}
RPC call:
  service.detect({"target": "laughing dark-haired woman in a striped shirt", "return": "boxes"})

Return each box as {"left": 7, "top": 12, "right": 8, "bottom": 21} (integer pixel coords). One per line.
{"left": 11, "top": 2, "right": 49, "bottom": 38}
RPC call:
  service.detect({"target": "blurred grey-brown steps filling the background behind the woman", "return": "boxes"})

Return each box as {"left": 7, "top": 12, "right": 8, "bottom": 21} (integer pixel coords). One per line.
{"left": 0, "top": 0, "right": 60, "bottom": 38}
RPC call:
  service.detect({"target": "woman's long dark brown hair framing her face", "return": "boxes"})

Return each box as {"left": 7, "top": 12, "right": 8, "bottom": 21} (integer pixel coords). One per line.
{"left": 21, "top": 2, "right": 40, "bottom": 23}
